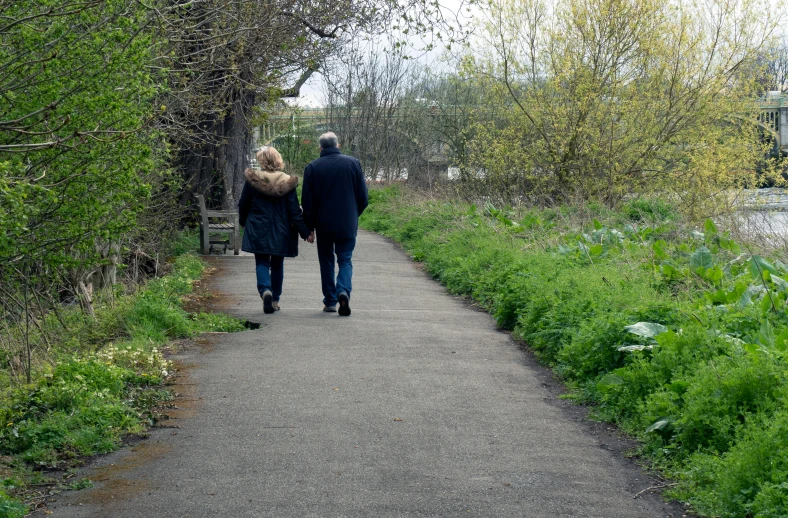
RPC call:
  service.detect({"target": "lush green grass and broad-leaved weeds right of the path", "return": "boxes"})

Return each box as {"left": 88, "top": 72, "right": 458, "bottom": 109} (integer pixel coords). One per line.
{"left": 361, "top": 188, "right": 788, "bottom": 517}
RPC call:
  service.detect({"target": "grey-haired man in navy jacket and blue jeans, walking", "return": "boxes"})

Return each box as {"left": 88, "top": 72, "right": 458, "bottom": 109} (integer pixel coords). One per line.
{"left": 301, "top": 132, "right": 369, "bottom": 316}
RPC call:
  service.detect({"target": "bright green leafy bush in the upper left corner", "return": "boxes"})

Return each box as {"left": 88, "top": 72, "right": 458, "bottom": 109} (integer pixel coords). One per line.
{"left": 0, "top": 0, "right": 163, "bottom": 268}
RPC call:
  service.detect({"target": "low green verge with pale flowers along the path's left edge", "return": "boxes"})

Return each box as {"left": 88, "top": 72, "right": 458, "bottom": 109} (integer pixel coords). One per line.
{"left": 0, "top": 255, "right": 244, "bottom": 517}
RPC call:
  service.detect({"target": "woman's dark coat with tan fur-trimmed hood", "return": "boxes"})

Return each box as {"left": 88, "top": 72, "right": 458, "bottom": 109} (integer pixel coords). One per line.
{"left": 238, "top": 169, "right": 309, "bottom": 257}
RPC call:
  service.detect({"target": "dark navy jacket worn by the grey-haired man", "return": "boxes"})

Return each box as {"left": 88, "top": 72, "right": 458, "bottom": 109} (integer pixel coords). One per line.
{"left": 301, "top": 147, "right": 369, "bottom": 240}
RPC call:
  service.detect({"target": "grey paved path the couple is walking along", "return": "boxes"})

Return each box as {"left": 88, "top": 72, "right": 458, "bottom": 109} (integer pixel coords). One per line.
{"left": 50, "top": 233, "right": 676, "bottom": 518}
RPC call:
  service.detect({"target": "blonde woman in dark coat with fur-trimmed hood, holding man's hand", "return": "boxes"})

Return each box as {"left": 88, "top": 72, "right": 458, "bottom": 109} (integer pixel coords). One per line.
{"left": 238, "top": 146, "right": 310, "bottom": 313}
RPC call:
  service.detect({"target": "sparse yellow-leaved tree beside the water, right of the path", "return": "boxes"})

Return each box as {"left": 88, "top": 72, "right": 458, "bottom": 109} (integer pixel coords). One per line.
{"left": 462, "top": 0, "right": 778, "bottom": 217}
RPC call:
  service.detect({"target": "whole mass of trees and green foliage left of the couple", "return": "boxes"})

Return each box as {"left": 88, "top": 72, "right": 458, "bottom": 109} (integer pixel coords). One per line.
{"left": 0, "top": 0, "right": 464, "bottom": 382}
